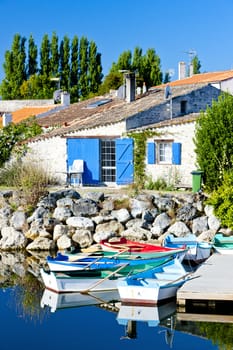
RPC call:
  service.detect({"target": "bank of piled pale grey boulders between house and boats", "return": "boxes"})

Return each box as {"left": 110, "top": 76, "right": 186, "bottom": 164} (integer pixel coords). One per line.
{"left": 0, "top": 188, "right": 228, "bottom": 251}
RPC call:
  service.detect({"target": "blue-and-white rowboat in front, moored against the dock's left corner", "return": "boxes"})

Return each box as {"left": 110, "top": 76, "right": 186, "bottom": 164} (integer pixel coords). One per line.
{"left": 117, "top": 258, "right": 191, "bottom": 305}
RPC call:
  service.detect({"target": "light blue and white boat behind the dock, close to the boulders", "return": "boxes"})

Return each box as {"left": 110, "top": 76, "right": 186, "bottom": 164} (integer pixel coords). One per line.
{"left": 163, "top": 234, "right": 213, "bottom": 264}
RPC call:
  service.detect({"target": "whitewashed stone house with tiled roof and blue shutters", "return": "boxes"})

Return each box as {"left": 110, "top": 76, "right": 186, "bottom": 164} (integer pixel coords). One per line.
{"left": 18, "top": 70, "right": 233, "bottom": 187}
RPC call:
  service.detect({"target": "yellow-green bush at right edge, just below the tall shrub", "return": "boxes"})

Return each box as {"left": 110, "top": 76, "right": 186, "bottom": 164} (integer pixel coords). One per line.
{"left": 207, "top": 171, "right": 233, "bottom": 229}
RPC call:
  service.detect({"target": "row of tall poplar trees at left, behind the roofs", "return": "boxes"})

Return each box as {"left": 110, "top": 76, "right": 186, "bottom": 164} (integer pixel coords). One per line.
{"left": 0, "top": 32, "right": 103, "bottom": 102}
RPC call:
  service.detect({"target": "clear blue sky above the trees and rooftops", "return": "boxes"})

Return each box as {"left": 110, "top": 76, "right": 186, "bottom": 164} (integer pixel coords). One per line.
{"left": 0, "top": 0, "right": 233, "bottom": 82}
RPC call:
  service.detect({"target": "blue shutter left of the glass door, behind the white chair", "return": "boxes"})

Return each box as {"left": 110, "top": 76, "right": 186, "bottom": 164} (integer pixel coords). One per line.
{"left": 67, "top": 138, "right": 100, "bottom": 185}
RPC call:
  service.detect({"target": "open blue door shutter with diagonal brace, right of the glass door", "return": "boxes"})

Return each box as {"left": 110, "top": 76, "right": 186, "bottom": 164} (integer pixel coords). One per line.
{"left": 116, "top": 139, "right": 134, "bottom": 185}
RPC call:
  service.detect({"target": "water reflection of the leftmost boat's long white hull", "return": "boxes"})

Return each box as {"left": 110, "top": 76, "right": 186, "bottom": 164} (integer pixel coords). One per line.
{"left": 40, "top": 288, "right": 120, "bottom": 312}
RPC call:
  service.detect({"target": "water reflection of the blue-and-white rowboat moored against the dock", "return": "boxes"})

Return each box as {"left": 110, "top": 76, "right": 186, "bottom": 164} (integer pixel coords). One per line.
{"left": 117, "top": 300, "right": 176, "bottom": 327}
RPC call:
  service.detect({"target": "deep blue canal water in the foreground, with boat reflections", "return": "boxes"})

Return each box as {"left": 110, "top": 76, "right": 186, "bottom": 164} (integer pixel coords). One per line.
{"left": 0, "top": 284, "right": 233, "bottom": 350}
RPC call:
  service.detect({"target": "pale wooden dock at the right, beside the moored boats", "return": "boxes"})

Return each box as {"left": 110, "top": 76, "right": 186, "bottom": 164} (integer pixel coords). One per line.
{"left": 177, "top": 253, "right": 233, "bottom": 309}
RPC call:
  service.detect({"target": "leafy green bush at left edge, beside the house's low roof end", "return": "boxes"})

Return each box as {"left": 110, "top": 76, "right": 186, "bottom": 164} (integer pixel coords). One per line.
{"left": 0, "top": 118, "right": 42, "bottom": 167}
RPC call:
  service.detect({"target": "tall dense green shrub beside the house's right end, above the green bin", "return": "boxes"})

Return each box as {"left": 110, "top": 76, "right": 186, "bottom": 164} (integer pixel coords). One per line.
{"left": 194, "top": 93, "right": 233, "bottom": 192}
